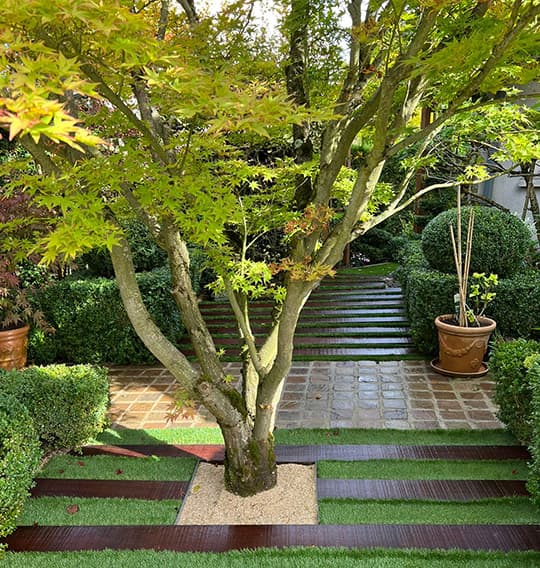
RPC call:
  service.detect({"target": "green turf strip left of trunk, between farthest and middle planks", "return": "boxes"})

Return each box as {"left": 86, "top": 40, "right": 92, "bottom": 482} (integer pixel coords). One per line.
{"left": 37, "top": 455, "right": 197, "bottom": 481}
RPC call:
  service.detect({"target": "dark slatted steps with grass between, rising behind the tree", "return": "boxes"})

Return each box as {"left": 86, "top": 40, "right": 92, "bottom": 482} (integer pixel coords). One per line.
{"left": 180, "top": 271, "right": 421, "bottom": 361}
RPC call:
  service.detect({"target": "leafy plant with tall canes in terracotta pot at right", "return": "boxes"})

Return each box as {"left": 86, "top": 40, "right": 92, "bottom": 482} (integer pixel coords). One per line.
{"left": 431, "top": 200, "right": 498, "bottom": 377}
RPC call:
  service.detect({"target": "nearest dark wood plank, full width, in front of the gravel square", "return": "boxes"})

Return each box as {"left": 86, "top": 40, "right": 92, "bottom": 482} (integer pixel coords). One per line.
{"left": 5, "top": 524, "right": 540, "bottom": 552}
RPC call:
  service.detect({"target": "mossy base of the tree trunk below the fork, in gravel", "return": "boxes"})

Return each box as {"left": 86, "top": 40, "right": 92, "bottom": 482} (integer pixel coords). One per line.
{"left": 221, "top": 424, "right": 277, "bottom": 497}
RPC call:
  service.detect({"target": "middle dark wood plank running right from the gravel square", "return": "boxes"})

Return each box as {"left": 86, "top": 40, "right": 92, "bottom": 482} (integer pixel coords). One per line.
{"left": 317, "top": 479, "right": 528, "bottom": 501}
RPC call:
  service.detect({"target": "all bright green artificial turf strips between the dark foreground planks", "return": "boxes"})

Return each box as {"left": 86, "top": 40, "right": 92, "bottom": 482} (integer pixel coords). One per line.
{"left": 8, "top": 428, "right": 540, "bottom": 568}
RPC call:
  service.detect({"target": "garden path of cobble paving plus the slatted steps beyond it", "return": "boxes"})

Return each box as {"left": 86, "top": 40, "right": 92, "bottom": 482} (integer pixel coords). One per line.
{"left": 110, "top": 270, "right": 502, "bottom": 429}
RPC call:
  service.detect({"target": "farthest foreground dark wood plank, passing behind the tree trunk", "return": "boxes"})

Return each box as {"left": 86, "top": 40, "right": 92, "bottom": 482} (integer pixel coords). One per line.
{"left": 83, "top": 444, "right": 531, "bottom": 464}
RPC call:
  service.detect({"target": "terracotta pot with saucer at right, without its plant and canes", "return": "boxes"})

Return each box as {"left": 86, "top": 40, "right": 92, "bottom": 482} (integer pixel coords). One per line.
{"left": 432, "top": 314, "right": 497, "bottom": 377}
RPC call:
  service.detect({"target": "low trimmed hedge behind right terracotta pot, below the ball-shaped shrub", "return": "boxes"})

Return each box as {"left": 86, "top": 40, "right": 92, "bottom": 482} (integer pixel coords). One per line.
{"left": 396, "top": 242, "right": 540, "bottom": 354}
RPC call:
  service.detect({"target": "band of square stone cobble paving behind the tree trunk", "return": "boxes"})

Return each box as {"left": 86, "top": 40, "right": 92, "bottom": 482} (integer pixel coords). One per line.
{"left": 110, "top": 361, "right": 503, "bottom": 429}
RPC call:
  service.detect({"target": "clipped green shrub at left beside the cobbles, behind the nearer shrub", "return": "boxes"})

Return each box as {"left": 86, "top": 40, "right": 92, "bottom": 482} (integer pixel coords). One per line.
{"left": 0, "top": 365, "right": 109, "bottom": 451}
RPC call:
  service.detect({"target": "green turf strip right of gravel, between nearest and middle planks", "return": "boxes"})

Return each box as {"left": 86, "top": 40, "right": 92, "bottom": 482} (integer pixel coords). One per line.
{"left": 319, "top": 497, "right": 540, "bottom": 525}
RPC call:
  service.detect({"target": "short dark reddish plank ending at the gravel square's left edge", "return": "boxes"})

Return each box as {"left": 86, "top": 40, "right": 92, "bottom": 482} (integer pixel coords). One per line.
{"left": 31, "top": 478, "right": 188, "bottom": 500}
